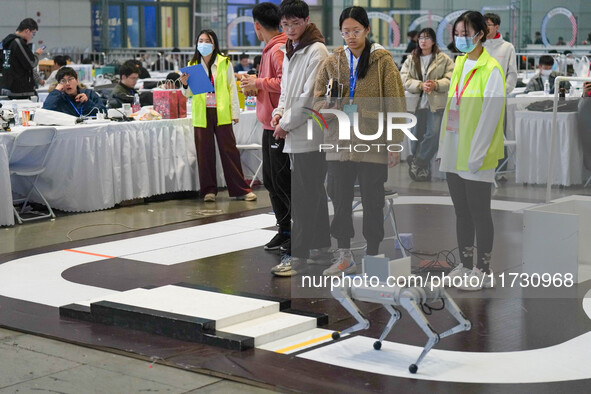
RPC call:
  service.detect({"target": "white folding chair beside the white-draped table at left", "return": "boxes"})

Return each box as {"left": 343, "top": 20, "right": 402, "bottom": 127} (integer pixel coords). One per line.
{"left": 8, "top": 127, "right": 57, "bottom": 224}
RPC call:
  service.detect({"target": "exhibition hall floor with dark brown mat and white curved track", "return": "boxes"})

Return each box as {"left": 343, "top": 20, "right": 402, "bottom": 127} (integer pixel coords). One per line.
{"left": 0, "top": 165, "right": 591, "bottom": 393}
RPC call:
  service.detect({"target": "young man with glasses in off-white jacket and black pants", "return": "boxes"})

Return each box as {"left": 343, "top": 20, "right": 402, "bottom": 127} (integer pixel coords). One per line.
{"left": 271, "top": 0, "right": 330, "bottom": 276}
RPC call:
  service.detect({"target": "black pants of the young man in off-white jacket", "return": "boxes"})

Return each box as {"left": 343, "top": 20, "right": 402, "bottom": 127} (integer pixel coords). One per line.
{"left": 290, "top": 152, "right": 330, "bottom": 258}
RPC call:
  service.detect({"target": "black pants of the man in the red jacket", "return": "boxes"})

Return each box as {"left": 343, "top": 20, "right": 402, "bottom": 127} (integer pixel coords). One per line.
{"left": 263, "top": 130, "right": 291, "bottom": 233}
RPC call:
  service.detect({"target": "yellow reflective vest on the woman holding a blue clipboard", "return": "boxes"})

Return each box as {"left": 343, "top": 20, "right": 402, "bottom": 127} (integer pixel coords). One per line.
{"left": 189, "top": 54, "right": 232, "bottom": 127}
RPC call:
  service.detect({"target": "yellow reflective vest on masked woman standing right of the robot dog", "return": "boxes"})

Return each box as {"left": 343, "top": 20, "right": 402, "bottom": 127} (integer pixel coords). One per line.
{"left": 441, "top": 48, "right": 505, "bottom": 171}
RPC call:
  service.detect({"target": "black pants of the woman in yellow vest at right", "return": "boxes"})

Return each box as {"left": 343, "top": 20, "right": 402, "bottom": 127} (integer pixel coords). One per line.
{"left": 446, "top": 172, "right": 494, "bottom": 270}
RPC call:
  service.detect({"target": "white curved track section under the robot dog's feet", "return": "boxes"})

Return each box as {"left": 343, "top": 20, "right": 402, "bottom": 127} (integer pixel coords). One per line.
{"left": 298, "top": 332, "right": 591, "bottom": 383}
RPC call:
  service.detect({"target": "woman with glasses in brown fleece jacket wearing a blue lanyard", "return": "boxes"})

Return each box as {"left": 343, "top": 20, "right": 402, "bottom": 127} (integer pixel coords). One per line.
{"left": 314, "top": 6, "right": 406, "bottom": 275}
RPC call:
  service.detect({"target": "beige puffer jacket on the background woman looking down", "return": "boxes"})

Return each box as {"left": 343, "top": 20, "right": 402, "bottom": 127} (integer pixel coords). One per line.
{"left": 400, "top": 52, "right": 454, "bottom": 112}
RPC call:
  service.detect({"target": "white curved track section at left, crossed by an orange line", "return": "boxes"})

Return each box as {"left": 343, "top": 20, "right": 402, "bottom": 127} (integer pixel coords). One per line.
{"left": 0, "top": 214, "right": 275, "bottom": 308}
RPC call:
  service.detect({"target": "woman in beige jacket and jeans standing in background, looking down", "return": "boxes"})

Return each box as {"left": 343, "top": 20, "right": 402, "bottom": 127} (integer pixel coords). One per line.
{"left": 400, "top": 28, "right": 454, "bottom": 182}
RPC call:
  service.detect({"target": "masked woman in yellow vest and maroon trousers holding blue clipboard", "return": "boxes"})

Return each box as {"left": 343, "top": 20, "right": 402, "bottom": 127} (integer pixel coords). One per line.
{"left": 180, "top": 30, "right": 257, "bottom": 202}
